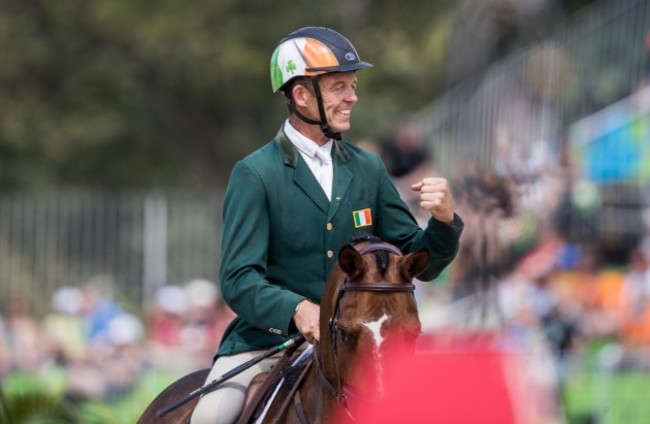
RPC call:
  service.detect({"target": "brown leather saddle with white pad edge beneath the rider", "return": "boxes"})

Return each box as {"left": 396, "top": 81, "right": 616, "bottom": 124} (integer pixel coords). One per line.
{"left": 237, "top": 346, "right": 313, "bottom": 424}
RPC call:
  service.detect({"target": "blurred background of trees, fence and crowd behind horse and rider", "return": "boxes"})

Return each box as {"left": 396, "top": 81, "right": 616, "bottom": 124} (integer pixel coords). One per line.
{"left": 0, "top": 0, "right": 650, "bottom": 424}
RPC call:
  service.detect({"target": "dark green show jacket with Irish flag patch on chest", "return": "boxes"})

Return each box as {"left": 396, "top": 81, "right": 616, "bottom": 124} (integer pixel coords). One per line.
{"left": 217, "top": 129, "right": 463, "bottom": 355}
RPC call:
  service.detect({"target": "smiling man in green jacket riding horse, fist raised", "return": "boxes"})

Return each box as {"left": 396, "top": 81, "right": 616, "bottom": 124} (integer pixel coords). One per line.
{"left": 192, "top": 27, "right": 463, "bottom": 424}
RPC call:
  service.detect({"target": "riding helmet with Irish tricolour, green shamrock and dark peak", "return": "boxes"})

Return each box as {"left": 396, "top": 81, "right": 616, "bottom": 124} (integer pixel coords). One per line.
{"left": 271, "top": 27, "right": 372, "bottom": 93}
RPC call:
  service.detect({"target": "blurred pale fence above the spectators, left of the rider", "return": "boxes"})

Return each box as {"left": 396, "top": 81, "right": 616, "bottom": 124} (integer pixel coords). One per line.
{"left": 0, "top": 192, "right": 221, "bottom": 313}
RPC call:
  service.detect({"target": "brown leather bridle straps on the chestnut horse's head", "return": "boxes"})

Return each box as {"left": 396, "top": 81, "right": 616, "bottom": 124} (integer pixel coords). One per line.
{"left": 313, "top": 243, "right": 415, "bottom": 419}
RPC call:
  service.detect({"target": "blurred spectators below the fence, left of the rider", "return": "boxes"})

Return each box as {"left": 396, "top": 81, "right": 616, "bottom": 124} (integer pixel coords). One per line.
{"left": 0, "top": 279, "right": 233, "bottom": 400}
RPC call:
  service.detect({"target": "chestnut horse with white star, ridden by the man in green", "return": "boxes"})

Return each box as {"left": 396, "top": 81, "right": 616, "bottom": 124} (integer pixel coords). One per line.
{"left": 138, "top": 236, "right": 429, "bottom": 424}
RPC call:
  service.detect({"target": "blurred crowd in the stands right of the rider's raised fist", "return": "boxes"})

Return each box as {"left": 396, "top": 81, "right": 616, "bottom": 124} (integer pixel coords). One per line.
{"left": 370, "top": 117, "right": 650, "bottom": 378}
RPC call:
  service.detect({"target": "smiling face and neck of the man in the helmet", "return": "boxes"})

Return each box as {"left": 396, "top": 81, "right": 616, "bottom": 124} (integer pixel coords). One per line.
{"left": 291, "top": 71, "right": 358, "bottom": 144}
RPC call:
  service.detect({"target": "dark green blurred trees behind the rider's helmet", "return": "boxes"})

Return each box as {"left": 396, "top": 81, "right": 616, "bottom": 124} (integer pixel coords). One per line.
{"left": 0, "top": 0, "right": 451, "bottom": 189}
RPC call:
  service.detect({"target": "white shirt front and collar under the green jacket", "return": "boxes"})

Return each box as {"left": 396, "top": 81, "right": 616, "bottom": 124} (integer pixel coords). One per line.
{"left": 284, "top": 120, "right": 334, "bottom": 201}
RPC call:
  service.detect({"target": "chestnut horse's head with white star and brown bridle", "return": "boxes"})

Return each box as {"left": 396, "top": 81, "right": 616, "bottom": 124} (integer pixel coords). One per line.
{"left": 317, "top": 237, "right": 429, "bottom": 420}
